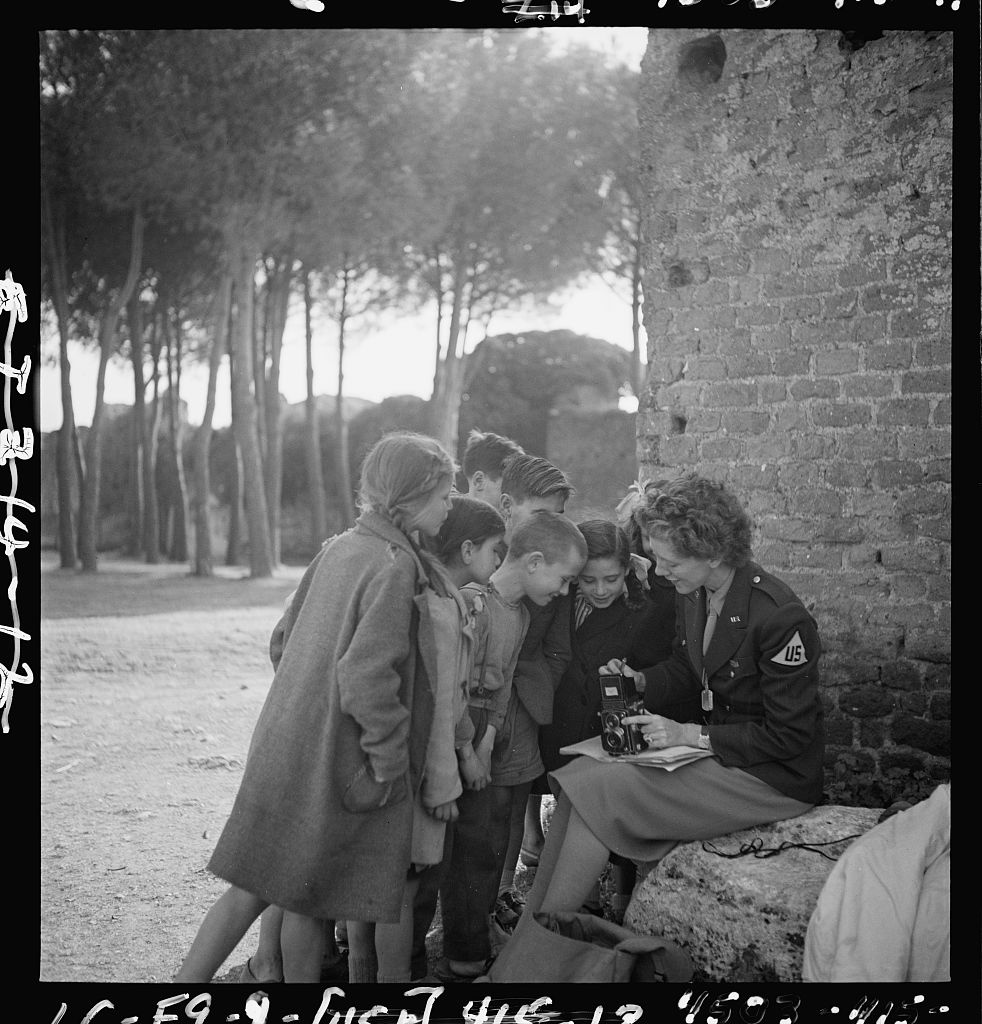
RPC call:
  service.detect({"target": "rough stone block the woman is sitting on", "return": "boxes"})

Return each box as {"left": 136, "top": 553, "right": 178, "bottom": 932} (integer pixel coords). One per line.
{"left": 624, "top": 805, "right": 883, "bottom": 982}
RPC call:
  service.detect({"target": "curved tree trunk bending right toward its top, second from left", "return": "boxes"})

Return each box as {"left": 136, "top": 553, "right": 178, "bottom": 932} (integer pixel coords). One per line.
{"left": 79, "top": 207, "right": 143, "bottom": 572}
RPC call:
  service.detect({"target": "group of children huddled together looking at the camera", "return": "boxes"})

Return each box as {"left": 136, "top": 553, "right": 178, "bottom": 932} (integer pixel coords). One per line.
{"left": 174, "top": 432, "right": 675, "bottom": 983}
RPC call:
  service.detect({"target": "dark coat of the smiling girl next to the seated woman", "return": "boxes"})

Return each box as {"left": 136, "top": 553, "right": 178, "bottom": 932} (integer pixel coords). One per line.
{"left": 539, "top": 584, "right": 675, "bottom": 771}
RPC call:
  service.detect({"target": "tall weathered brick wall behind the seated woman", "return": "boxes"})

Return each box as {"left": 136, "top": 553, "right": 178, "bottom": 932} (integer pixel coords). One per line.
{"left": 638, "top": 30, "right": 950, "bottom": 805}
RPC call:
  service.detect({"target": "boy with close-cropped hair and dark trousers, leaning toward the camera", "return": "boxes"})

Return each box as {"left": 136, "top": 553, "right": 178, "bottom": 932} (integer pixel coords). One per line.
{"left": 440, "top": 509, "right": 587, "bottom": 981}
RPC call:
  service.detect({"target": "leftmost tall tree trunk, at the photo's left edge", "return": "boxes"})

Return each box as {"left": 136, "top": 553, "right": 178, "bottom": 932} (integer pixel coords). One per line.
{"left": 41, "top": 188, "right": 82, "bottom": 569}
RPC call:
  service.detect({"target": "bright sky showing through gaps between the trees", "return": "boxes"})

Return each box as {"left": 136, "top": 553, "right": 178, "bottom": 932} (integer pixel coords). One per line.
{"left": 40, "top": 28, "right": 647, "bottom": 431}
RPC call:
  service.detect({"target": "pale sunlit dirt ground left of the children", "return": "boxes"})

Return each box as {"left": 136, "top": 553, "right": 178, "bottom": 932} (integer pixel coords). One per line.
{"left": 40, "top": 559, "right": 302, "bottom": 982}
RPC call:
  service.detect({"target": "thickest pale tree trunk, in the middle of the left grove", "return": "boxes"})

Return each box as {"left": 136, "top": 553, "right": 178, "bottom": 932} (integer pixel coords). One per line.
{"left": 231, "top": 245, "right": 272, "bottom": 578}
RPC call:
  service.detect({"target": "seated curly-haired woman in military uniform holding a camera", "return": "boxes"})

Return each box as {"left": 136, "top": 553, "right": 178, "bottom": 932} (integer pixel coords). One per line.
{"left": 526, "top": 473, "right": 824, "bottom": 912}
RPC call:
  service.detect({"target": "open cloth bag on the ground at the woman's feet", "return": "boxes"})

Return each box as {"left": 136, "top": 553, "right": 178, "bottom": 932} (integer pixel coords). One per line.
{"left": 477, "top": 912, "right": 692, "bottom": 983}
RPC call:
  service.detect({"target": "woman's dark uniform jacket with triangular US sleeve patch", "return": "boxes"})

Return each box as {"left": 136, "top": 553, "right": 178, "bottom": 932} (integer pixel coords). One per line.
{"left": 644, "top": 562, "right": 824, "bottom": 804}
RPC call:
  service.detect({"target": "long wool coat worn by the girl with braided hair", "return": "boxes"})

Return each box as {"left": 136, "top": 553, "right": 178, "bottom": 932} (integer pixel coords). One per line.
{"left": 208, "top": 512, "right": 436, "bottom": 922}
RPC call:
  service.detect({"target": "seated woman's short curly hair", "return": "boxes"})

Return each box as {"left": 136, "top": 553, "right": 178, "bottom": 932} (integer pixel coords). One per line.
{"left": 635, "top": 473, "right": 753, "bottom": 568}
